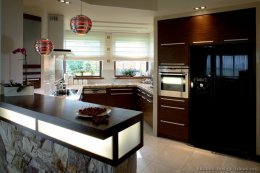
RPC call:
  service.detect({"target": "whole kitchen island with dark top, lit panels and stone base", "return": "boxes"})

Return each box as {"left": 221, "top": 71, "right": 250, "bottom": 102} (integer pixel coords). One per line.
{"left": 0, "top": 94, "right": 143, "bottom": 172}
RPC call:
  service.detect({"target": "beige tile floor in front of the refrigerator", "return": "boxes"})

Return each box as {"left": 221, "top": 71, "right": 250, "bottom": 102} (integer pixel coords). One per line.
{"left": 137, "top": 124, "right": 260, "bottom": 173}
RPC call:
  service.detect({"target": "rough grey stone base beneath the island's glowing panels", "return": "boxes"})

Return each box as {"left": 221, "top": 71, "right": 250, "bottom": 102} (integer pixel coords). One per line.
{"left": 0, "top": 121, "right": 136, "bottom": 173}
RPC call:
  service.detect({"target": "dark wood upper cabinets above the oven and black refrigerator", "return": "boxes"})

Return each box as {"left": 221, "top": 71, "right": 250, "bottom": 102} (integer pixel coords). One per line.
{"left": 158, "top": 8, "right": 256, "bottom": 65}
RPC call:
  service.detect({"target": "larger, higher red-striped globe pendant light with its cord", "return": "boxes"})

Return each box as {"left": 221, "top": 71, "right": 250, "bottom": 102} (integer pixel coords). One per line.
{"left": 70, "top": 0, "right": 92, "bottom": 35}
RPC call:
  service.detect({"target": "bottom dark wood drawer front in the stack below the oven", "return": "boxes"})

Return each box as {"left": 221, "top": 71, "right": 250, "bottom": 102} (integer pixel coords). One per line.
{"left": 158, "top": 121, "right": 189, "bottom": 142}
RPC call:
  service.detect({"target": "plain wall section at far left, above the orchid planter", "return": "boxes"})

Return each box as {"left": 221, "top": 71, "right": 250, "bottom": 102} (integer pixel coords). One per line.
{"left": 1, "top": 0, "right": 23, "bottom": 82}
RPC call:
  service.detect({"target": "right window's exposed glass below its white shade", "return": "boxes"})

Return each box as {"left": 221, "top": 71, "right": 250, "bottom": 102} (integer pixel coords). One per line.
{"left": 115, "top": 61, "right": 148, "bottom": 77}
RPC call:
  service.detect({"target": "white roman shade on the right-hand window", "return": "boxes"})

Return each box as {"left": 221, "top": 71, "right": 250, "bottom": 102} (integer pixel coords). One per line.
{"left": 112, "top": 33, "right": 150, "bottom": 61}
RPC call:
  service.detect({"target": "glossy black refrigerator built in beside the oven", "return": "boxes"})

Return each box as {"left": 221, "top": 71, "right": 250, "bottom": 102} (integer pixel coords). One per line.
{"left": 190, "top": 43, "right": 256, "bottom": 157}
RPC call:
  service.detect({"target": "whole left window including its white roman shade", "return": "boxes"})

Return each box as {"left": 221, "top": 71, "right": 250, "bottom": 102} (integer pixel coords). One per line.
{"left": 64, "top": 31, "right": 105, "bottom": 78}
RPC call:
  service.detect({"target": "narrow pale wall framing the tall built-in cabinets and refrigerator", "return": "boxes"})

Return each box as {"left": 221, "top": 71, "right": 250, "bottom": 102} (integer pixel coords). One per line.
{"left": 153, "top": 2, "right": 260, "bottom": 156}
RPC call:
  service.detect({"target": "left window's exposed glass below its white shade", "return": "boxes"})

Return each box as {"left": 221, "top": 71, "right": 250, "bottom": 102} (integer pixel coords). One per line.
{"left": 66, "top": 60, "right": 102, "bottom": 77}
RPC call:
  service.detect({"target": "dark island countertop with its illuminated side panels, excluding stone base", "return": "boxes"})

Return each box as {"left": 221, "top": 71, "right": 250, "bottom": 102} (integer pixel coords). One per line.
{"left": 0, "top": 94, "right": 143, "bottom": 166}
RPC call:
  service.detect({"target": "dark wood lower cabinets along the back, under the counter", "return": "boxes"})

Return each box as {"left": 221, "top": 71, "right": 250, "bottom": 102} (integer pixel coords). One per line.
{"left": 81, "top": 87, "right": 153, "bottom": 127}
